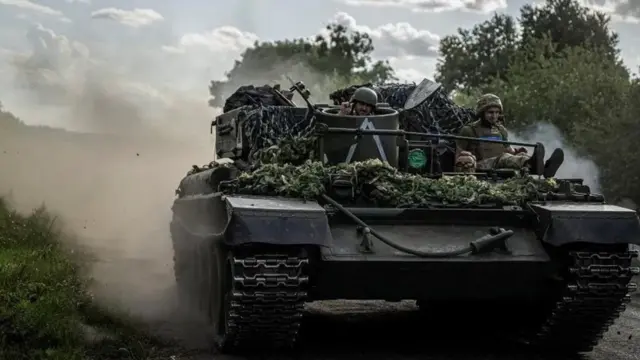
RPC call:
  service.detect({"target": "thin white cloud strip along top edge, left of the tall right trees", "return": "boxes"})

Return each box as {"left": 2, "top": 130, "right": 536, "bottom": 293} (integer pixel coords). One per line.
{"left": 336, "top": 0, "right": 507, "bottom": 14}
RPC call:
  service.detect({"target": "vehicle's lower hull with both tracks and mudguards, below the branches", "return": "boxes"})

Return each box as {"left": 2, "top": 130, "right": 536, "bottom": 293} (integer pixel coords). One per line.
{"left": 171, "top": 169, "right": 640, "bottom": 353}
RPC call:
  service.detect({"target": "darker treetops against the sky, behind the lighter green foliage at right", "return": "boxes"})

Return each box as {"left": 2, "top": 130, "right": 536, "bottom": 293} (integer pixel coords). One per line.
{"left": 436, "top": 0, "right": 621, "bottom": 91}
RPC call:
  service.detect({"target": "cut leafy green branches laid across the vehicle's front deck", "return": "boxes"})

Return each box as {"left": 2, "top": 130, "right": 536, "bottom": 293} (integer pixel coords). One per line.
{"left": 221, "top": 159, "right": 557, "bottom": 207}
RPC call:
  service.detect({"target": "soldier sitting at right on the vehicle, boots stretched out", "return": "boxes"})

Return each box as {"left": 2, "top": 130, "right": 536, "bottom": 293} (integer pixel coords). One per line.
{"left": 456, "top": 94, "right": 564, "bottom": 178}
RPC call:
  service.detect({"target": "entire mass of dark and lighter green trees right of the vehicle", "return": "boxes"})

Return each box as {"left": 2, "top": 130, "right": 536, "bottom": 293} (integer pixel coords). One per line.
{"left": 436, "top": 0, "right": 640, "bottom": 203}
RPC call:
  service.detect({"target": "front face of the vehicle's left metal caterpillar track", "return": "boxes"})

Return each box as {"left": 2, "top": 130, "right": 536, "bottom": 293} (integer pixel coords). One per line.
{"left": 212, "top": 249, "right": 309, "bottom": 353}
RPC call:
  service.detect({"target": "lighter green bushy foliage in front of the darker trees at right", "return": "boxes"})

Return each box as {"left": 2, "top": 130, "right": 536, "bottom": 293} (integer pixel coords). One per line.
{"left": 488, "top": 37, "right": 640, "bottom": 202}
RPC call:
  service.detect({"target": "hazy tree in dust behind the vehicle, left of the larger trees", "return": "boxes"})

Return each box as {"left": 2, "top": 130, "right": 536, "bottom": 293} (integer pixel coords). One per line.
{"left": 209, "top": 24, "right": 394, "bottom": 106}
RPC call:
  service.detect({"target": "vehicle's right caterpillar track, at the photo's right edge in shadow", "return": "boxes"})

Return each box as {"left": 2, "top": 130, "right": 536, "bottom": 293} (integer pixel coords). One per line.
{"left": 533, "top": 251, "right": 640, "bottom": 353}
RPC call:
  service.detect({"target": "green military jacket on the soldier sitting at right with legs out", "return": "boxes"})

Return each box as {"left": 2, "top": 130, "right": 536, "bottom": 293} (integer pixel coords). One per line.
{"left": 456, "top": 120, "right": 509, "bottom": 161}
